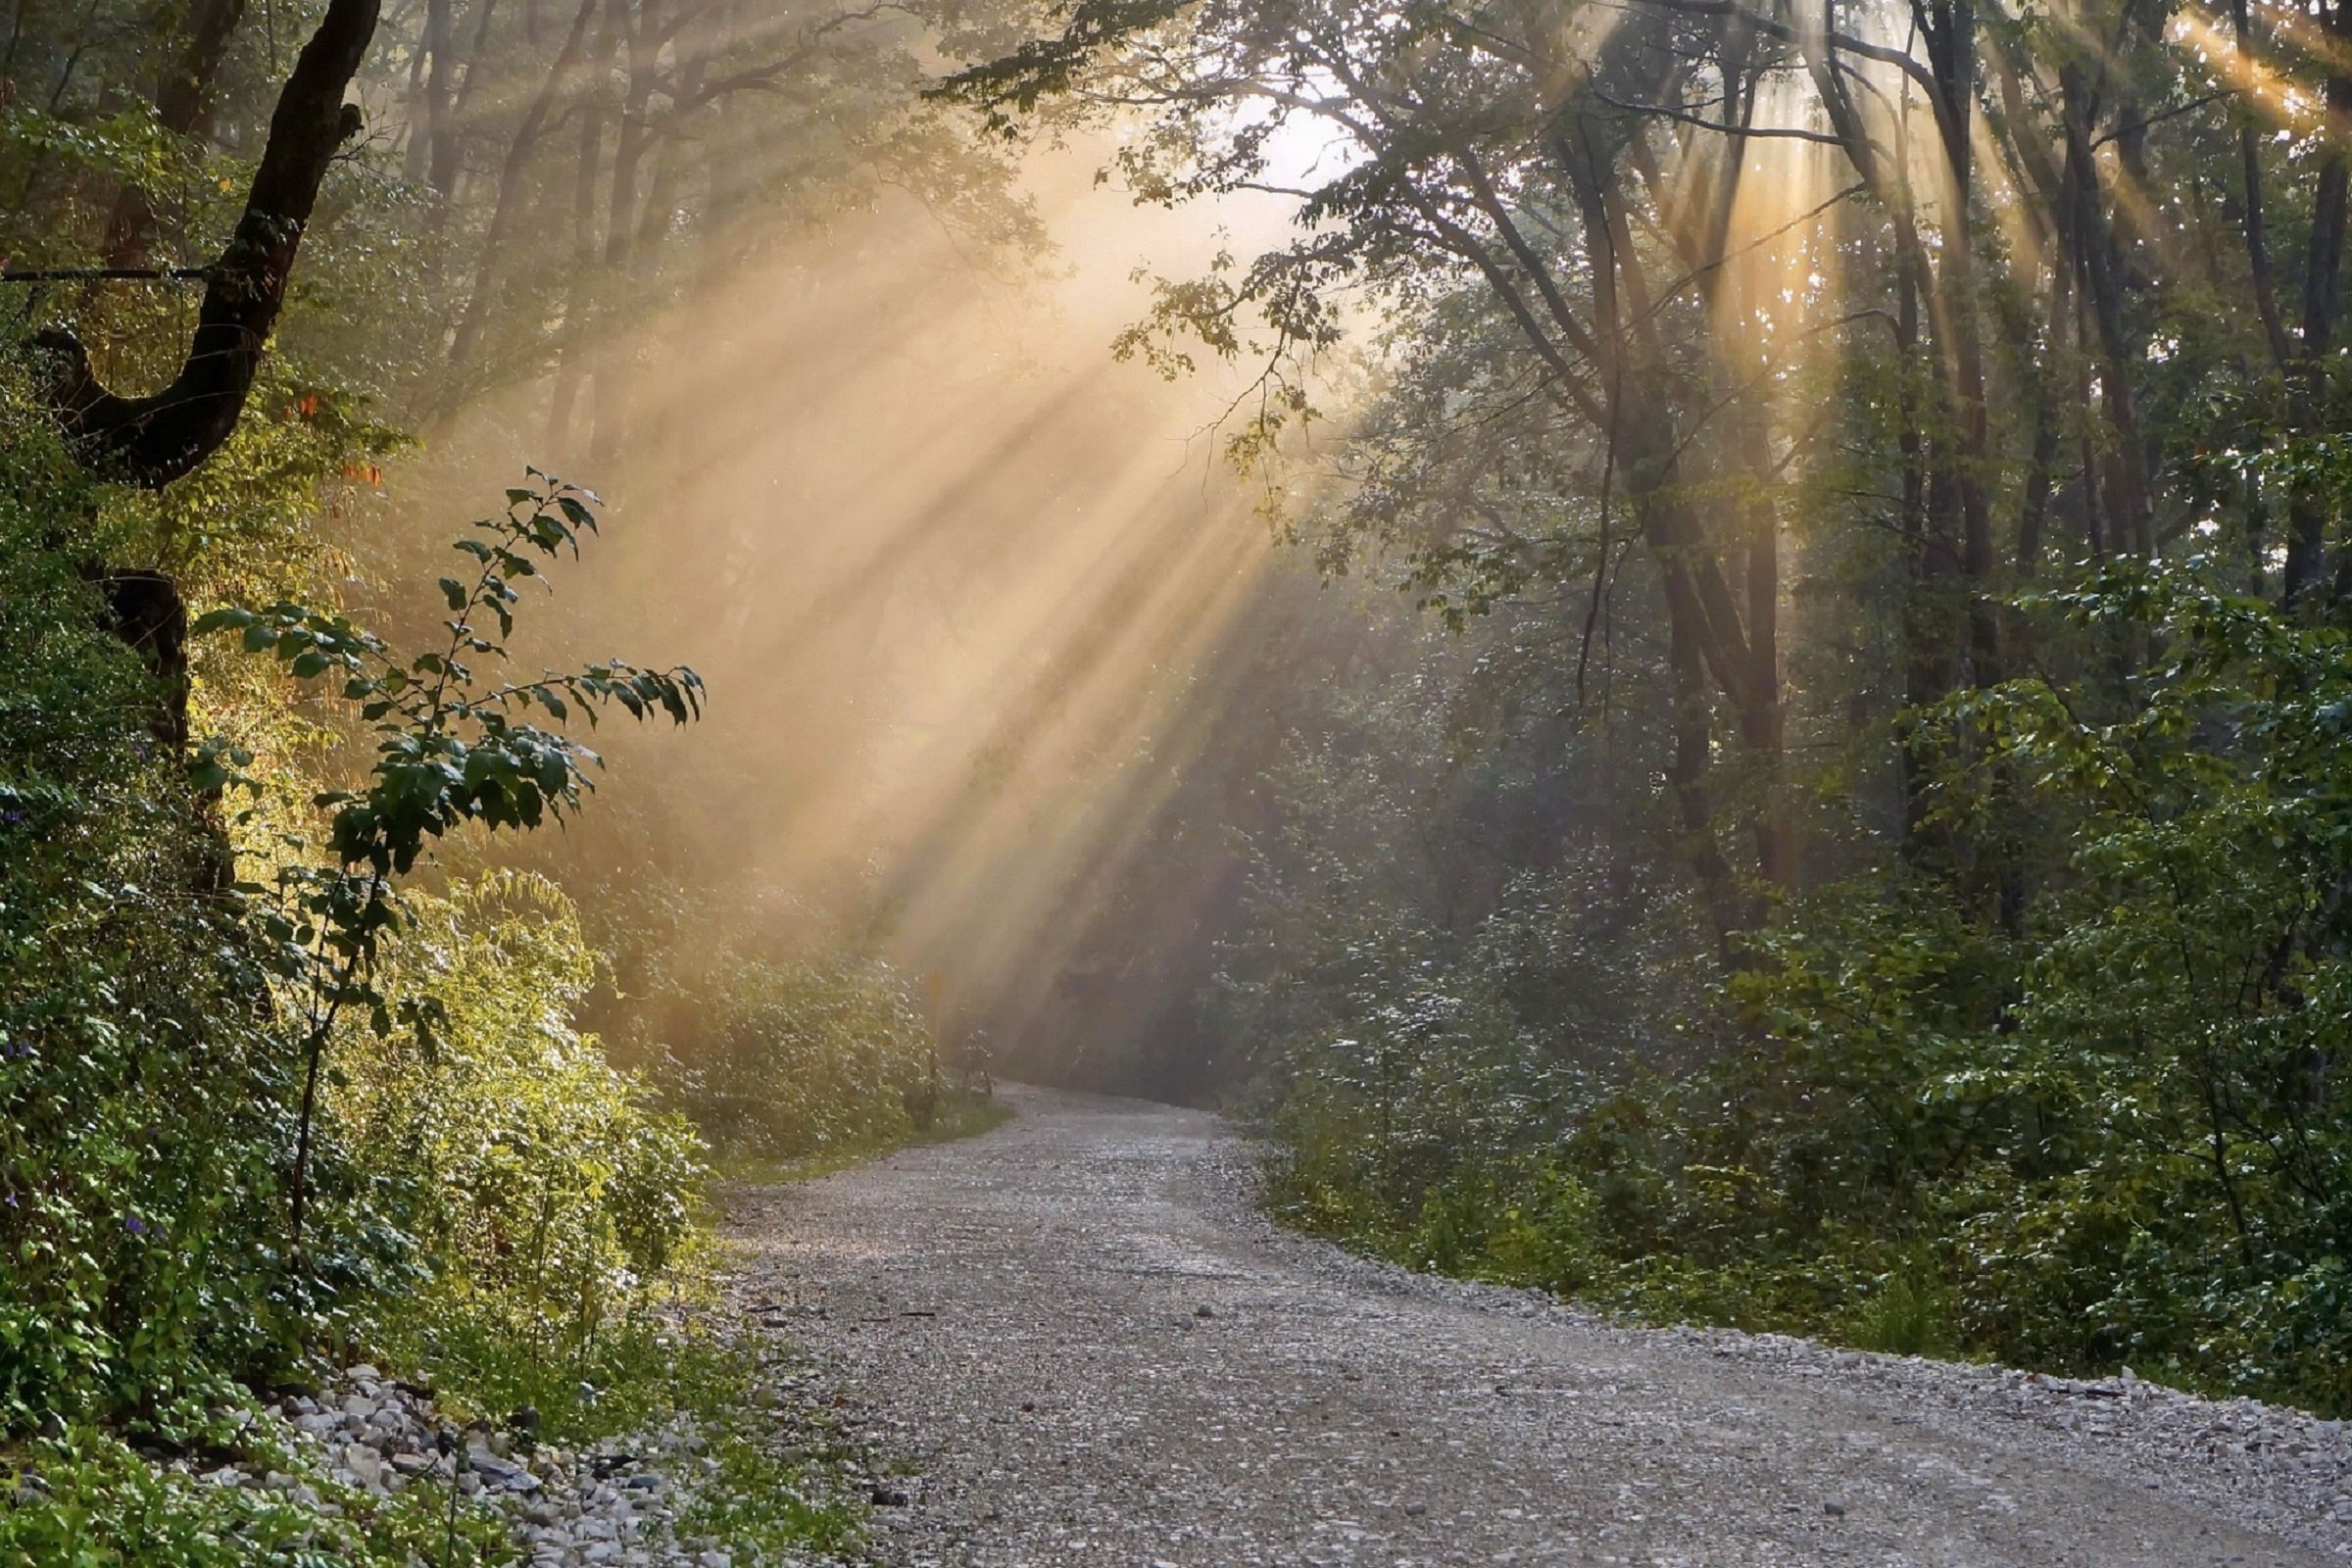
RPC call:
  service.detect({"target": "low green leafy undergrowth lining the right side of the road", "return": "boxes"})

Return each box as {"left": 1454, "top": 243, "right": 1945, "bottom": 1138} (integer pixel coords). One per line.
{"left": 1245, "top": 562, "right": 2352, "bottom": 1413}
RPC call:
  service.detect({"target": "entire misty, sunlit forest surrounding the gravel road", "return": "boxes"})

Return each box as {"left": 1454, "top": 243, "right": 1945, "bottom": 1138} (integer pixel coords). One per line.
{"left": 0, "top": 0, "right": 2352, "bottom": 1551}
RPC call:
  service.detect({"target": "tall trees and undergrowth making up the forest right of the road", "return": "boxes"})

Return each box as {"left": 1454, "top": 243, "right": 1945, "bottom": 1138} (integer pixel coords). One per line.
{"left": 921, "top": 0, "right": 2352, "bottom": 1408}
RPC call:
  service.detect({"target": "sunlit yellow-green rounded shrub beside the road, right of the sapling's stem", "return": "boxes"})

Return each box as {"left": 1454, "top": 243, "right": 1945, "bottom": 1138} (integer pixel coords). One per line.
{"left": 329, "top": 872, "right": 706, "bottom": 1359}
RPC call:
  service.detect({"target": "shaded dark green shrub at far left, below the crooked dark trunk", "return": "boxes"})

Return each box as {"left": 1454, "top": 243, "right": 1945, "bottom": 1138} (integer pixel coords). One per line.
{"left": 0, "top": 439, "right": 318, "bottom": 1429}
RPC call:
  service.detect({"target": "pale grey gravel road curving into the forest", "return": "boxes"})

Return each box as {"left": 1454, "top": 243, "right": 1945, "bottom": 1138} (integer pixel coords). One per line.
{"left": 731, "top": 1091, "right": 2352, "bottom": 1568}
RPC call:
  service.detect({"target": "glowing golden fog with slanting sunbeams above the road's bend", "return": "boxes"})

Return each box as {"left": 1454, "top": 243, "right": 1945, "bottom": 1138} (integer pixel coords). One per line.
{"left": 407, "top": 141, "right": 1315, "bottom": 1077}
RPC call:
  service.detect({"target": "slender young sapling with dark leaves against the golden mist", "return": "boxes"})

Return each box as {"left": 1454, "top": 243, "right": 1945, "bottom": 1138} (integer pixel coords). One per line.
{"left": 193, "top": 470, "right": 704, "bottom": 1253}
